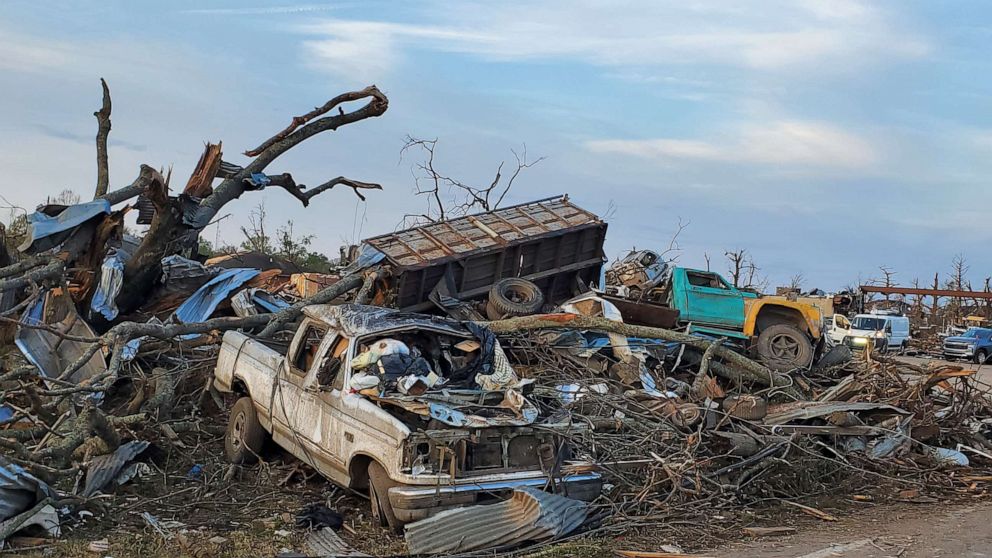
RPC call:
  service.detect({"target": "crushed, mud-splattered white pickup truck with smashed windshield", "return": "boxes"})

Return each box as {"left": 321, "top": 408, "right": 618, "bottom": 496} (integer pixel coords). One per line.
{"left": 214, "top": 305, "right": 602, "bottom": 530}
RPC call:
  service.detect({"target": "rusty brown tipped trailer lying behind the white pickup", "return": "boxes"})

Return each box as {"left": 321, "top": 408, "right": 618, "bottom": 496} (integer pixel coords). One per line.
{"left": 365, "top": 196, "right": 606, "bottom": 311}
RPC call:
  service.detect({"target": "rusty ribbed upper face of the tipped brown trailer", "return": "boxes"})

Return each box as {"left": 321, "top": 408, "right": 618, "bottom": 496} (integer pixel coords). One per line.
{"left": 365, "top": 196, "right": 602, "bottom": 269}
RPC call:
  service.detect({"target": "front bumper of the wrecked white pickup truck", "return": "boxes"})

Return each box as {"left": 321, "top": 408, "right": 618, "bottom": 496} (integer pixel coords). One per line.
{"left": 389, "top": 473, "right": 603, "bottom": 523}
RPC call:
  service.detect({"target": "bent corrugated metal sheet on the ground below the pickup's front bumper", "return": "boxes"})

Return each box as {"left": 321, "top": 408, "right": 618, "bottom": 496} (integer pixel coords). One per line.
{"left": 406, "top": 488, "right": 589, "bottom": 554}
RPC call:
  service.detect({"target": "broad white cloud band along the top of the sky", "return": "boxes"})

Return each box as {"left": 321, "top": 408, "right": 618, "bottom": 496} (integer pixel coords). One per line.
{"left": 300, "top": 0, "right": 930, "bottom": 81}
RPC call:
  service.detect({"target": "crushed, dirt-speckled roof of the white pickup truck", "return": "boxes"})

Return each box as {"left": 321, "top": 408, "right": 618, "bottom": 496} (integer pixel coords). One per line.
{"left": 303, "top": 304, "right": 472, "bottom": 337}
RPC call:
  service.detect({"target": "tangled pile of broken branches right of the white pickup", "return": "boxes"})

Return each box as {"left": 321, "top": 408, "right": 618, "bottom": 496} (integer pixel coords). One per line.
{"left": 494, "top": 328, "right": 992, "bottom": 542}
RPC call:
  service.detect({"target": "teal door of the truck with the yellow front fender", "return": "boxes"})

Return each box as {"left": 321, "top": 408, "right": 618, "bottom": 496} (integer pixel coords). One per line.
{"left": 680, "top": 269, "right": 744, "bottom": 329}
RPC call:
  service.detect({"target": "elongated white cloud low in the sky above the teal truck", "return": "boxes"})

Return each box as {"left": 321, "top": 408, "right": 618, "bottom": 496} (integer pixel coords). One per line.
{"left": 586, "top": 120, "right": 878, "bottom": 169}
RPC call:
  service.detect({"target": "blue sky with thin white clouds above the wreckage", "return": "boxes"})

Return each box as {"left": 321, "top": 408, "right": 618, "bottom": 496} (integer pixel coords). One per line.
{"left": 0, "top": 0, "right": 992, "bottom": 289}
